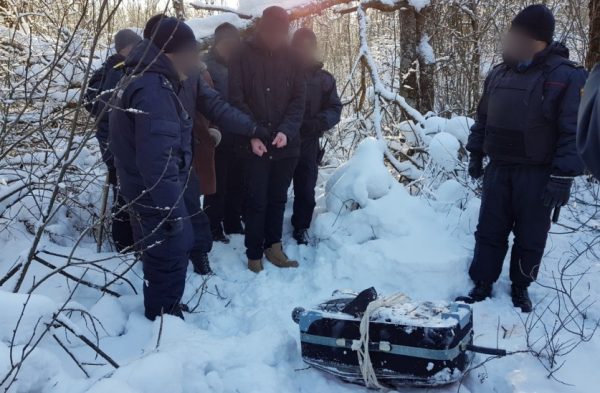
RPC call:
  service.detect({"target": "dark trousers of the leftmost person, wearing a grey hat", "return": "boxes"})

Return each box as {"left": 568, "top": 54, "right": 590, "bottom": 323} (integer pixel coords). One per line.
{"left": 108, "top": 168, "right": 133, "bottom": 252}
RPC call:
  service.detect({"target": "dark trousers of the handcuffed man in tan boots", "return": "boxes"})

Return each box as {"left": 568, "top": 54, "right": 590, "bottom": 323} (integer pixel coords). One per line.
{"left": 243, "top": 156, "right": 298, "bottom": 259}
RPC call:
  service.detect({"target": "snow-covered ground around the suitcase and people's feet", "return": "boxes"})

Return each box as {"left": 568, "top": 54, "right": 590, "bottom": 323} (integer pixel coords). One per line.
{"left": 0, "top": 140, "right": 600, "bottom": 393}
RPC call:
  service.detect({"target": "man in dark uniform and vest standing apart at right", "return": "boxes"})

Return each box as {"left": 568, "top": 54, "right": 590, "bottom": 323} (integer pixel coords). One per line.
{"left": 459, "top": 5, "right": 586, "bottom": 312}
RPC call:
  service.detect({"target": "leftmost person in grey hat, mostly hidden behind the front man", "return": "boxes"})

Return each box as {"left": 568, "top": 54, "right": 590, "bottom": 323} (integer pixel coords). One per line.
{"left": 85, "top": 29, "right": 142, "bottom": 252}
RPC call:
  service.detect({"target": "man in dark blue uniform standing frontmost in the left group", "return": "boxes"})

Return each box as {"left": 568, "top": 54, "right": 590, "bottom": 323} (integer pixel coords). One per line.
{"left": 109, "top": 18, "right": 260, "bottom": 320}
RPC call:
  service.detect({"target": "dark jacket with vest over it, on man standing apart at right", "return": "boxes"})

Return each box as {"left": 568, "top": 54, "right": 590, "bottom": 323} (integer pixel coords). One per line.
{"left": 467, "top": 43, "right": 587, "bottom": 176}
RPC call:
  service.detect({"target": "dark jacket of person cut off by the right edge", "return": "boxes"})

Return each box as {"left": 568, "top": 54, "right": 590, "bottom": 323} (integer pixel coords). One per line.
{"left": 577, "top": 65, "right": 600, "bottom": 179}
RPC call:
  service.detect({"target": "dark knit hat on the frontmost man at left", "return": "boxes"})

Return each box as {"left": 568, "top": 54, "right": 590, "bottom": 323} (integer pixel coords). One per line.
{"left": 150, "top": 17, "right": 198, "bottom": 53}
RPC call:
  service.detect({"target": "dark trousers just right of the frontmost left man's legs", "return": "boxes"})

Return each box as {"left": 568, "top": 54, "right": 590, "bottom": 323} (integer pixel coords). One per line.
{"left": 183, "top": 170, "right": 212, "bottom": 261}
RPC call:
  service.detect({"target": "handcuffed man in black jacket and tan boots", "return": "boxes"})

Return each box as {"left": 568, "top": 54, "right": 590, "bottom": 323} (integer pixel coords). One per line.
{"left": 229, "top": 6, "right": 306, "bottom": 273}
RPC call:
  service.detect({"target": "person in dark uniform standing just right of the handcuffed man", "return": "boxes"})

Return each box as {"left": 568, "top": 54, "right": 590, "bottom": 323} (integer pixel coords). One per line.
{"left": 292, "top": 28, "right": 342, "bottom": 244}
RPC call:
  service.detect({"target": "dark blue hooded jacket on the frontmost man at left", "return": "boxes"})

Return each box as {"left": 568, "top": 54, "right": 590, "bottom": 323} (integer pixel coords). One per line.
{"left": 109, "top": 40, "right": 192, "bottom": 218}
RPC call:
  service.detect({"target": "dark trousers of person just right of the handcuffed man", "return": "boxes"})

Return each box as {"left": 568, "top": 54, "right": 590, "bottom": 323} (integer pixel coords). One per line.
{"left": 292, "top": 138, "right": 319, "bottom": 229}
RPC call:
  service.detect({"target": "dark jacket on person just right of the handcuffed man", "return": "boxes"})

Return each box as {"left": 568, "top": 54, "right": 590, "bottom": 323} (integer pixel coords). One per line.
{"left": 300, "top": 63, "right": 343, "bottom": 140}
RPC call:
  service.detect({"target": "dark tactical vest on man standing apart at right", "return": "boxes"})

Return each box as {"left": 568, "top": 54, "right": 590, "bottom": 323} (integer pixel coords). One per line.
{"left": 483, "top": 55, "right": 573, "bottom": 165}
